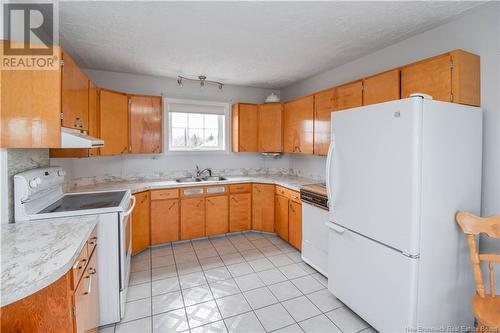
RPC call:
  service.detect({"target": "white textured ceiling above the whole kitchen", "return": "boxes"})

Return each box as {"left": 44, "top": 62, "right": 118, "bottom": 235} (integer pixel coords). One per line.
{"left": 59, "top": 1, "right": 481, "bottom": 88}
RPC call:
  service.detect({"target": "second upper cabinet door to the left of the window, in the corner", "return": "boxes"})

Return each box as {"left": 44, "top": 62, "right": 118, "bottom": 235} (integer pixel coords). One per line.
{"left": 99, "top": 89, "right": 129, "bottom": 155}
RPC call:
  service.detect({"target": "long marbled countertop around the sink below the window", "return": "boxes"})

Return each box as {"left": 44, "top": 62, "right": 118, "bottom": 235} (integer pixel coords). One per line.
{"left": 71, "top": 175, "right": 319, "bottom": 193}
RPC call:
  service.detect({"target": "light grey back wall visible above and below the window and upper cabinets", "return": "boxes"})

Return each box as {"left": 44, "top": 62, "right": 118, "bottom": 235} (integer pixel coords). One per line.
{"left": 50, "top": 70, "right": 289, "bottom": 187}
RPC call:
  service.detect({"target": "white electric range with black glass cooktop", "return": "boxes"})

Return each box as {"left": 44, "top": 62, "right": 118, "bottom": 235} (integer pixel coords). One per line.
{"left": 14, "top": 167, "right": 135, "bottom": 325}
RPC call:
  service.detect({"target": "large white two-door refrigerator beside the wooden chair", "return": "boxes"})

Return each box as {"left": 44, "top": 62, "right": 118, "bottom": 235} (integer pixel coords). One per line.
{"left": 326, "top": 97, "right": 482, "bottom": 332}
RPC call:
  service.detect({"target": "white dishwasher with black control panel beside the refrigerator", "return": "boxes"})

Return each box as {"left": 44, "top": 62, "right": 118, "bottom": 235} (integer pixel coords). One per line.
{"left": 300, "top": 184, "right": 328, "bottom": 277}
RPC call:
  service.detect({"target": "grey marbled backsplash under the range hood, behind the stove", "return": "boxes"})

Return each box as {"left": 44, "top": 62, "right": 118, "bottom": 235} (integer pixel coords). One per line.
{"left": 7, "top": 149, "right": 50, "bottom": 222}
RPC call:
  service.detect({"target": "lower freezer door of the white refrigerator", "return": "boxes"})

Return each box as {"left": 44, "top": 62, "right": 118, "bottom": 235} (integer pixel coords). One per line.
{"left": 328, "top": 220, "right": 419, "bottom": 332}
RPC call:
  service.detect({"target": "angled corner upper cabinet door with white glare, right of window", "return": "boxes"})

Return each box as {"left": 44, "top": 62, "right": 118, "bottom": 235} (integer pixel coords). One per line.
{"left": 283, "top": 96, "right": 314, "bottom": 154}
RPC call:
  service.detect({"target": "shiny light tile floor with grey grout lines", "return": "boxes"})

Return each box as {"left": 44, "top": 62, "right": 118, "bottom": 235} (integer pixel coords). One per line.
{"left": 100, "top": 232, "right": 375, "bottom": 333}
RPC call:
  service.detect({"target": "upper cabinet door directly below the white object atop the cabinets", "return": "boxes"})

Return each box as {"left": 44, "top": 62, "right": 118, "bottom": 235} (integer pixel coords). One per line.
{"left": 258, "top": 103, "right": 283, "bottom": 153}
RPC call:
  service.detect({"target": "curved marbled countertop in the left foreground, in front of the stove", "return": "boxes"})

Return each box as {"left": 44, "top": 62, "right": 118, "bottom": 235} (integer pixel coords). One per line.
{"left": 0, "top": 215, "right": 98, "bottom": 306}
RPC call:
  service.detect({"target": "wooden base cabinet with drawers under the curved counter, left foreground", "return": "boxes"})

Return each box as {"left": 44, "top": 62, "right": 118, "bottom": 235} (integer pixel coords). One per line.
{"left": 0, "top": 230, "right": 99, "bottom": 333}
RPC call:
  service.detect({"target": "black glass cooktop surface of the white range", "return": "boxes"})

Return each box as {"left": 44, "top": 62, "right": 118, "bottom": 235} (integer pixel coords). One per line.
{"left": 38, "top": 191, "right": 126, "bottom": 214}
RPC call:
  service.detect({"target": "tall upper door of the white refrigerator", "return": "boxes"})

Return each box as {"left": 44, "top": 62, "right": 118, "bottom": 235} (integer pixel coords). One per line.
{"left": 326, "top": 98, "right": 422, "bottom": 255}
